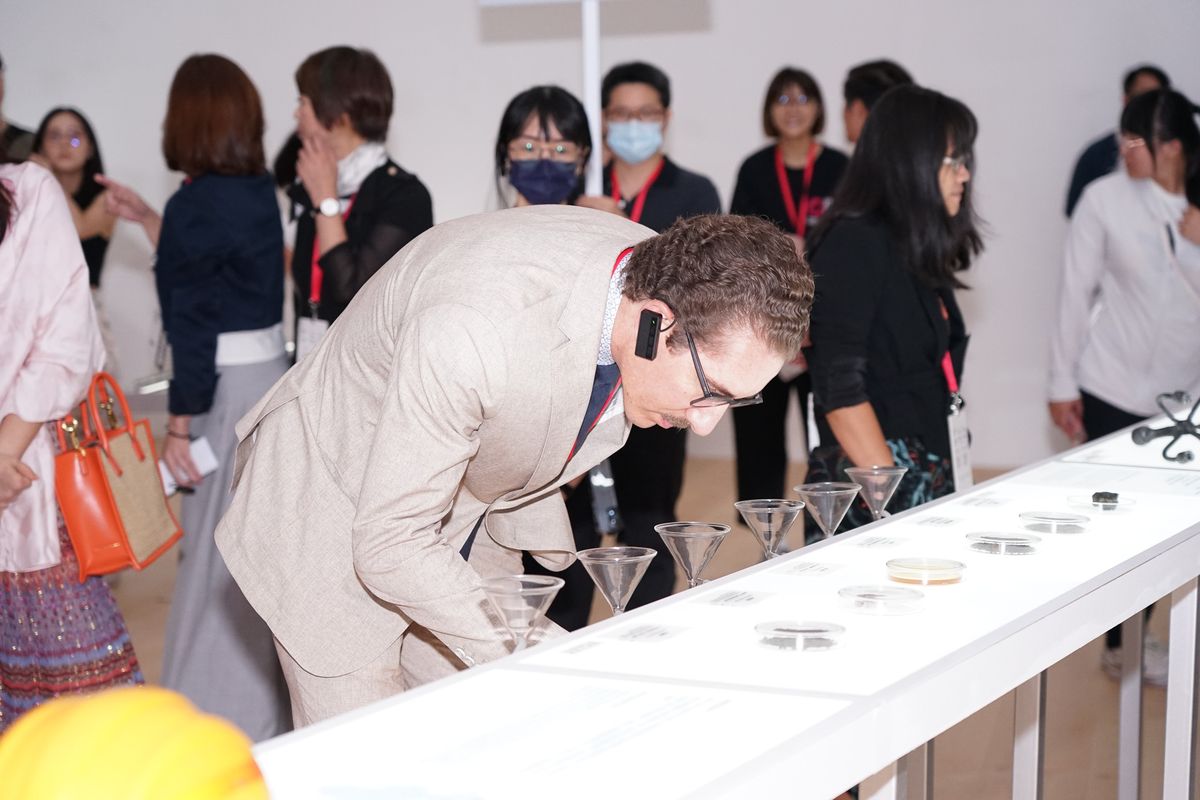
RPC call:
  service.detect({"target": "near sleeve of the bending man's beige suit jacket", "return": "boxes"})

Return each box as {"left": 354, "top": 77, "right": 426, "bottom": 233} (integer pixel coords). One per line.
{"left": 352, "top": 306, "right": 508, "bottom": 661}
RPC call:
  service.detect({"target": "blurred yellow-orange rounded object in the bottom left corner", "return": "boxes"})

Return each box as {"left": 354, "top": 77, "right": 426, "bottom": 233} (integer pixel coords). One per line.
{"left": 0, "top": 686, "right": 268, "bottom": 800}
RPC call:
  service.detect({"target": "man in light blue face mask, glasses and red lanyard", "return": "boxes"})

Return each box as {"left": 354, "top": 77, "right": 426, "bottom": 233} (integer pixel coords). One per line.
{"left": 578, "top": 61, "right": 721, "bottom": 618}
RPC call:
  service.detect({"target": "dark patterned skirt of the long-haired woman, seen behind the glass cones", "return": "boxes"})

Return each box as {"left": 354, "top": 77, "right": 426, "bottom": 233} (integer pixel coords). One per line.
{"left": 804, "top": 439, "right": 954, "bottom": 543}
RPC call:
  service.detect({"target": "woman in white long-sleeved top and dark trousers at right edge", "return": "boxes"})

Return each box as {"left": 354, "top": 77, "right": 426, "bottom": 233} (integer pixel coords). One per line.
{"left": 1049, "top": 89, "right": 1200, "bottom": 685}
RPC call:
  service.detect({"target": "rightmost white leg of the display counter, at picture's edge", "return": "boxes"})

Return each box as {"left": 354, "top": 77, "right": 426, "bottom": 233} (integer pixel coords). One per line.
{"left": 1163, "top": 578, "right": 1200, "bottom": 800}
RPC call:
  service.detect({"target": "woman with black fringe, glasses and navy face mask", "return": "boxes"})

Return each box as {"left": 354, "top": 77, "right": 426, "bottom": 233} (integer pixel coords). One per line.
{"left": 496, "top": 86, "right": 592, "bottom": 207}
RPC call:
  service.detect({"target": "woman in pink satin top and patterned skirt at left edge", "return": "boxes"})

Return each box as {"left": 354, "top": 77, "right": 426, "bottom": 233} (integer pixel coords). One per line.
{"left": 0, "top": 152, "right": 142, "bottom": 733}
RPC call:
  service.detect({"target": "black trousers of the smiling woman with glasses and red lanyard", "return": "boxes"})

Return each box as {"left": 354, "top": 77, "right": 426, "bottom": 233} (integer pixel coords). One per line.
{"left": 733, "top": 372, "right": 814, "bottom": 500}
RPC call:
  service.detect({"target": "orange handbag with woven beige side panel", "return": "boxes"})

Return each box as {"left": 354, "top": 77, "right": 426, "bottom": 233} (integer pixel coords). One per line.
{"left": 54, "top": 372, "right": 184, "bottom": 583}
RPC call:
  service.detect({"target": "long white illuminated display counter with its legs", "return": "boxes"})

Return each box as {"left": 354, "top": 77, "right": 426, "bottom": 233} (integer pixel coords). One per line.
{"left": 256, "top": 422, "right": 1200, "bottom": 800}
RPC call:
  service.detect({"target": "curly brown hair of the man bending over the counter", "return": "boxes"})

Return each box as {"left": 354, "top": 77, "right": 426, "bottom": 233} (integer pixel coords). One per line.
{"left": 623, "top": 213, "right": 814, "bottom": 356}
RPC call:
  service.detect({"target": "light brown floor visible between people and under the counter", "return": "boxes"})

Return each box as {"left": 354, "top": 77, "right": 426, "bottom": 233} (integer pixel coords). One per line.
{"left": 115, "top": 459, "right": 1166, "bottom": 800}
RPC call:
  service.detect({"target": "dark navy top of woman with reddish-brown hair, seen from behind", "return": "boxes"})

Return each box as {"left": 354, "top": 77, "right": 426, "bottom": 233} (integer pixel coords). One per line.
{"left": 155, "top": 173, "right": 283, "bottom": 415}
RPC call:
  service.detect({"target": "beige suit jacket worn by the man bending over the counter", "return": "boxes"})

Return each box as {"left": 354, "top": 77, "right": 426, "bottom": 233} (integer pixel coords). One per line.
{"left": 216, "top": 206, "right": 653, "bottom": 676}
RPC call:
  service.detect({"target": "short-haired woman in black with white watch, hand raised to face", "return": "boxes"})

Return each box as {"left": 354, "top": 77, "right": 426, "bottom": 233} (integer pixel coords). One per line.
{"left": 288, "top": 47, "right": 433, "bottom": 361}
